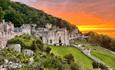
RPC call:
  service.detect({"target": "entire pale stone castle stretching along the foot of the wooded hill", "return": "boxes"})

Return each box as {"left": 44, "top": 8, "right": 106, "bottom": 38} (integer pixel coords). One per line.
{"left": 0, "top": 21, "right": 81, "bottom": 47}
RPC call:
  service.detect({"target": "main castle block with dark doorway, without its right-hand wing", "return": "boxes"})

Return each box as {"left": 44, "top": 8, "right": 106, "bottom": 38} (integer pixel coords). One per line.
{"left": 32, "top": 25, "right": 69, "bottom": 45}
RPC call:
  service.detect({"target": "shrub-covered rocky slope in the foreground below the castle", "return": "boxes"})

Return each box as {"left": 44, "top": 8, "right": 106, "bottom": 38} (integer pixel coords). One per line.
{"left": 0, "top": 35, "right": 79, "bottom": 70}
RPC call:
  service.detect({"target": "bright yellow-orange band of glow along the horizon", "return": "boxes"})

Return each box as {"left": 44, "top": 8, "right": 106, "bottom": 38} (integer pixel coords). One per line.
{"left": 78, "top": 25, "right": 115, "bottom": 38}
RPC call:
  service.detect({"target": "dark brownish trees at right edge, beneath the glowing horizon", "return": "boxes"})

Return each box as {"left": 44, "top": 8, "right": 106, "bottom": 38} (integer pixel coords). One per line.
{"left": 85, "top": 32, "right": 115, "bottom": 51}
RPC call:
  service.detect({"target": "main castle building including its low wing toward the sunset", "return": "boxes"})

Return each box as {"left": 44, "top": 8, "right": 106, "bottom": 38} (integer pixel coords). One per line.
{"left": 31, "top": 24, "right": 80, "bottom": 45}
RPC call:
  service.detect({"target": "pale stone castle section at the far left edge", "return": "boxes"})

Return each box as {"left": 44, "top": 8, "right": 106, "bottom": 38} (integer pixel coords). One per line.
{"left": 0, "top": 20, "right": 14, "bottom": 48}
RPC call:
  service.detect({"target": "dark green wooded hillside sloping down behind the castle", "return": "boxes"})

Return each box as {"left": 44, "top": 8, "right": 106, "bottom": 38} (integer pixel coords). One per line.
{"left": 0, "top": 0, "right": 76, "bottom": 30}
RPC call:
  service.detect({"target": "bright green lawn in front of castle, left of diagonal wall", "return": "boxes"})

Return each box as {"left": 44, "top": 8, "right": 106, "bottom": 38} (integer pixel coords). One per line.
{"left": 50, "top": 46, "right": 92, "bottom": 70}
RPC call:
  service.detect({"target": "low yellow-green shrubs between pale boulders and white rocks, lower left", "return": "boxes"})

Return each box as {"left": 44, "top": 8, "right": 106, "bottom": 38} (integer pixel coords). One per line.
{"left": 0, "top": 48, "right": 29, "bottom": 63}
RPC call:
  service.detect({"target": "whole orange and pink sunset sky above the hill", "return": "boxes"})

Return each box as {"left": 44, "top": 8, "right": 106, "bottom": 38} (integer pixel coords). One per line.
{"left": 15, "top": 0, "right": 115, "bottom": 38}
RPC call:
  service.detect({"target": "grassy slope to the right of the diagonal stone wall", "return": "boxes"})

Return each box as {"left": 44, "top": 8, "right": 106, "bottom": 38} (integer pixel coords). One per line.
{"left": 76, "top": 40, "right": 115, "bottom": 70}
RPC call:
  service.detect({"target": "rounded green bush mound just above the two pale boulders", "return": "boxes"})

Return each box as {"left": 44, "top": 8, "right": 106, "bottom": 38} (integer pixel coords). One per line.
{"left": 7, "top": 35, "right": 43, "bottom": 50}
